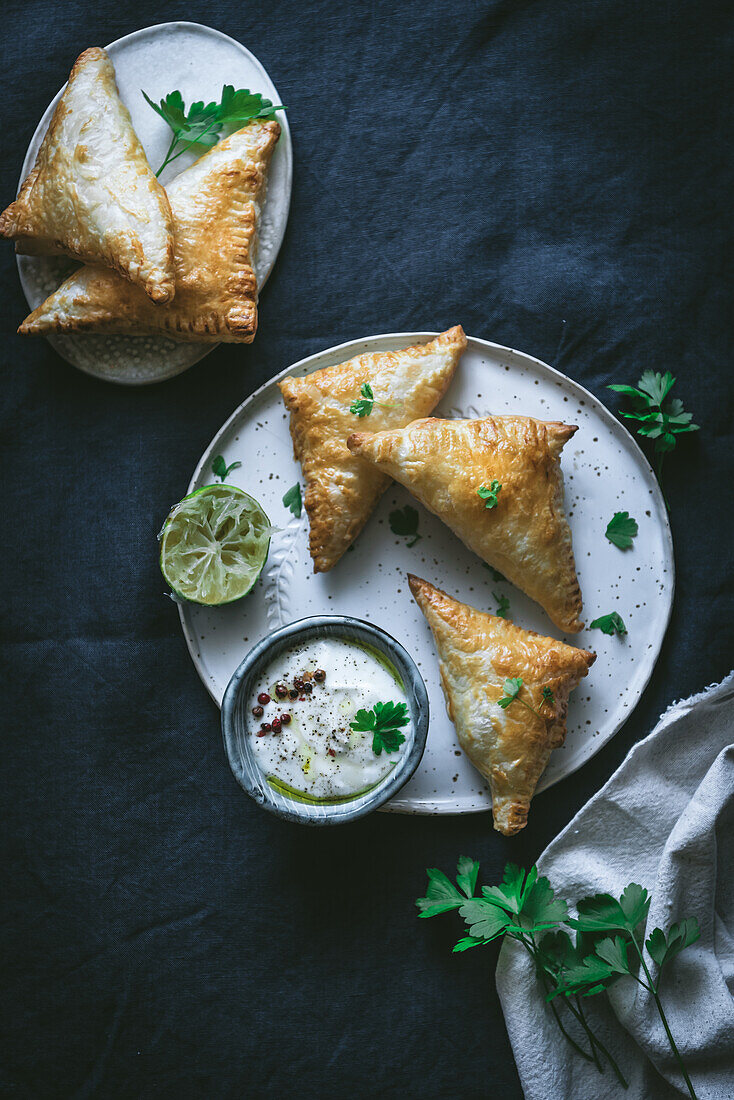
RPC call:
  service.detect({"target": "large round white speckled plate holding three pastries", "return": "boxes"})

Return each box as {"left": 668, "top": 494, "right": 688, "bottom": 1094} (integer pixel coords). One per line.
{"left": 174, "top": 332, "right": 673, "bottom": 813}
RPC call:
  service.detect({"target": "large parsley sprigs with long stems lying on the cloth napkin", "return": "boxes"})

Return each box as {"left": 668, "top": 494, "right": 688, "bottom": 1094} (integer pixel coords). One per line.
{"left": 416, "top": 856, "right": 700, "bottom": 1100}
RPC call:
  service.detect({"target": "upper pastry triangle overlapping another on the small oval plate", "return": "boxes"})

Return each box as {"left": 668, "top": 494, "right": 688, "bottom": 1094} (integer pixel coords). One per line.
{"left": 0, "top": 48, "right": 174, "bottom": 301}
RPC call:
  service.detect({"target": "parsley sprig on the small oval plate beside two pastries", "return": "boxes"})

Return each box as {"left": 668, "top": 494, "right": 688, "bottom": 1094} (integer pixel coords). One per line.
{"left": 141, "top": 84, "right": 285, "bottom": 176}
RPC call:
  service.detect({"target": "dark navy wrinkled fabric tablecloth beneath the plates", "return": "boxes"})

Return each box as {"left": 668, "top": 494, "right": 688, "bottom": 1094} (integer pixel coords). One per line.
{"left": 0, "top": 0, "right": 734, "bottom": 1100}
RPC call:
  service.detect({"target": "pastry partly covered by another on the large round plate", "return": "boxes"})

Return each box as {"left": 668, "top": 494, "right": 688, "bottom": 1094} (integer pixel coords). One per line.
{"left": 278, "top": 325, "right": 467, "bottom": 573}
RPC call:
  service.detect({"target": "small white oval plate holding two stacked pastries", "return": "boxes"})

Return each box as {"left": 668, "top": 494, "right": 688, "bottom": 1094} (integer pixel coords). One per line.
{"left": 18, "top": 23, "right": 293, "bottom": 385}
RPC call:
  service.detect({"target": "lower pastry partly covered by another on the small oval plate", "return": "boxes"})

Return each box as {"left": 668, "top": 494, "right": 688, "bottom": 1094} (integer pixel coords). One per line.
{"left": 18, "top": 121, "right": 281, "bottom": 343}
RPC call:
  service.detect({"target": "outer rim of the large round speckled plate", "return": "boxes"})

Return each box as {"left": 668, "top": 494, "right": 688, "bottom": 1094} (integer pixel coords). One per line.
{"left": 177, "top": 331, "right": 676, "bottom": 816}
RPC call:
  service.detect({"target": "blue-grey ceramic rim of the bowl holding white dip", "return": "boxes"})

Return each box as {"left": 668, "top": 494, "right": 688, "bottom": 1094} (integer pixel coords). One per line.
{"left": 221, "top": 615, "right": 429, "bottom": 825}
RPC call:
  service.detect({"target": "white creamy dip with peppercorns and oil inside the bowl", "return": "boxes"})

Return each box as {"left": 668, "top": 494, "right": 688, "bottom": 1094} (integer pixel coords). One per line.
{"left": 248, "top": 637, "right": 410, "bottom": 801}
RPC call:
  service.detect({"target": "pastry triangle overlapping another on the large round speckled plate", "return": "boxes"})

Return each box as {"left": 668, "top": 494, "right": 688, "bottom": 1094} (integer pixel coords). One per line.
{"left": 347, "top": 416, "right": 583, "bottom": 631}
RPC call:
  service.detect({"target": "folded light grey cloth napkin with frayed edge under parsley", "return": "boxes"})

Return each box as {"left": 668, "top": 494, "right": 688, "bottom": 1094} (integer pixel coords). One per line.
{"left": 496, "top": 673, "right": 734, "bottom": 1100}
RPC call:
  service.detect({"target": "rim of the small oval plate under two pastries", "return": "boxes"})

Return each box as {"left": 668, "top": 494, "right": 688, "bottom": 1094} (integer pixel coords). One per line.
{"left": 15, "top": 19, "right": 293, "bottom": 386}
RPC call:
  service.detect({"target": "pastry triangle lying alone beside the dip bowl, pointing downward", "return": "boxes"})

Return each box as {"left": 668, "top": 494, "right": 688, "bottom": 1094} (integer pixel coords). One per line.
{"left": 408, "top": 574, "right": 596, "bottom": 836}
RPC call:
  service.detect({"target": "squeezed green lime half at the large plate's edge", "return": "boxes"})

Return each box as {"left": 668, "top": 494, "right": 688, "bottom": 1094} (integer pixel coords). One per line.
{"left": 161, "top": 485, "right": 272, "bottom": 607}
